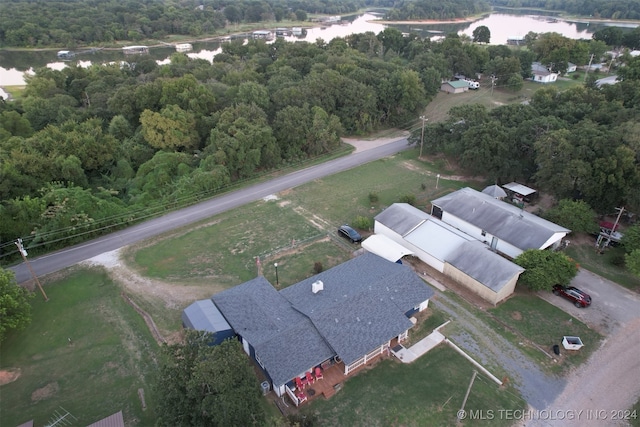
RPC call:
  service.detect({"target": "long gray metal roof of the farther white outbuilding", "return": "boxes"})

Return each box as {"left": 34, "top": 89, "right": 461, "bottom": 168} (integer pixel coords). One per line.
{"left": 431, "top": 187, "right": 571, "bottom": 251}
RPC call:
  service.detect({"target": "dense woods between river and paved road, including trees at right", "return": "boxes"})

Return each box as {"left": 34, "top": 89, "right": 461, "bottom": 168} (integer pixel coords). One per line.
{"left": 0, "top": 0, "right": 640, "bottom": 259}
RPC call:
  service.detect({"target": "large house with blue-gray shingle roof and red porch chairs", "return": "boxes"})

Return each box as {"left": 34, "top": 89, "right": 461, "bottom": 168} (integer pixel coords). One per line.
{"left": 212, "top": 253, "right": 433, "bottom": 403}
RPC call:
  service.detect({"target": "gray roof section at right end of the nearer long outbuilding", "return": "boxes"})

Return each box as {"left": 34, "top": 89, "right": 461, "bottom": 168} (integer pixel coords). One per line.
{"left": 446, "top": 240, "right": 524, "bottom": 292}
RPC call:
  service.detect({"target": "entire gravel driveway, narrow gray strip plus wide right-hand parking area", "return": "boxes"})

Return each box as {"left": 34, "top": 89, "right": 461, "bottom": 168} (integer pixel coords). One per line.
{"left": 432, "top": 270, "right": 640, "bottom": 427}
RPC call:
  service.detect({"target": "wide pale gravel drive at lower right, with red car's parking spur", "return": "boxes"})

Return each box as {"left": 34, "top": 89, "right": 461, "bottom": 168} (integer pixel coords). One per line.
{"left": 523, "top": 270, "right": 640, "bottom": 427}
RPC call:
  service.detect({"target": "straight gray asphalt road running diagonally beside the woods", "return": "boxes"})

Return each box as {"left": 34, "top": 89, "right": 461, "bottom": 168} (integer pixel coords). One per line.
{"left": 9, "top": 138, "right": 410, "bottom": 283}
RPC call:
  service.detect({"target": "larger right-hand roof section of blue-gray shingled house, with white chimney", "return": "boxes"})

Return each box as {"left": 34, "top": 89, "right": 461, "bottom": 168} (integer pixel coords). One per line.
{"left": 280, "top": 253, "right": 433, "bottom": 364}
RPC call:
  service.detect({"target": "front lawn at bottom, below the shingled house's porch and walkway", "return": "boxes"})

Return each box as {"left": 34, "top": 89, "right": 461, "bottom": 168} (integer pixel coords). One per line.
{"left": 301, "top": 344, "right": 525, "bottom": 426}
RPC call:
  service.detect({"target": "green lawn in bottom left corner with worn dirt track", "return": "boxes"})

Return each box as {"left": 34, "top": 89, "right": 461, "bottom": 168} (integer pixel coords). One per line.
{"left": 0, "top": 269, "right": 157, "bottom": 426}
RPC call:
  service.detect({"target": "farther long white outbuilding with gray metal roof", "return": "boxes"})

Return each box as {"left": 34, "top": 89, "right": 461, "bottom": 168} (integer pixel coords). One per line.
{"left": 431, "top": 187, "right": 571, "bottom": 258}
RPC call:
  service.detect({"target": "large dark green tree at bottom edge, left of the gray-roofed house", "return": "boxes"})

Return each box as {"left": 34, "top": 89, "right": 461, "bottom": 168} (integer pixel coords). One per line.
{"left": 155, "top": 330, "right": 266, "bottom": 427}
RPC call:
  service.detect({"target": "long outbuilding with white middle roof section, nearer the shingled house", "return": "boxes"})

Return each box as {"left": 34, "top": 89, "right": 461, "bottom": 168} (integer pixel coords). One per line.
{"left": 372, "top": 203, "right": 524, "bottom": 305}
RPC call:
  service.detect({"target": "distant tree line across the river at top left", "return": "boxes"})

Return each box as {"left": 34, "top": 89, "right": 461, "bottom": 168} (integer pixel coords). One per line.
{"left": 0, "top": 0, "right": 368, "bottom": 48}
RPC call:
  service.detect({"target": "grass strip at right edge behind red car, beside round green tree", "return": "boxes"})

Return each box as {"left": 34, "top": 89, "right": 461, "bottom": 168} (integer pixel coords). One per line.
{"left": 565, "top": 238, "right": 640, "bottom": 291}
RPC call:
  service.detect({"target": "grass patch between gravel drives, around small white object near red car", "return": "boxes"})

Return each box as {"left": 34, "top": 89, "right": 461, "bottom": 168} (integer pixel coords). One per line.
{"left": 489, "top": 292, "right": 603, "bottom": 373}
